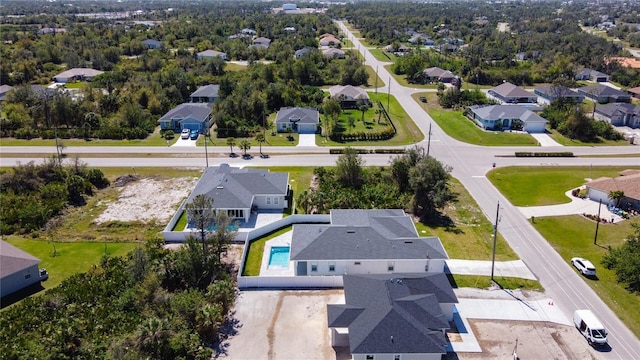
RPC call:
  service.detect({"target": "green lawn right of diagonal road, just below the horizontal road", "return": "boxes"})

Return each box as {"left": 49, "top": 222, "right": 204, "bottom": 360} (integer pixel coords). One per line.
{"left": 487, "top": 166, "right": 627, "bottom": 206}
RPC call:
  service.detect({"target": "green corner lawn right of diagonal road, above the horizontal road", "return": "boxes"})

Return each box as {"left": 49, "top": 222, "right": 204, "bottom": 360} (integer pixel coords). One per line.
{"left": 412, "top": 92, "right": 538, "bottom": 146}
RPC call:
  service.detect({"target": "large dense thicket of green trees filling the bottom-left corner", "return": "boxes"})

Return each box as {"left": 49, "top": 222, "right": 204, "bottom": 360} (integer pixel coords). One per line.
{"left": 0, "top": 239, "right": 235, "bottom": 359}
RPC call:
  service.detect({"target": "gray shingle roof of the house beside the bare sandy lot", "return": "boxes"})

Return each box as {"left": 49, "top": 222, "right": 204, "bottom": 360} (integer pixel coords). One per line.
{"left": 187, "top": 164, "right": 289, "bottom": 209}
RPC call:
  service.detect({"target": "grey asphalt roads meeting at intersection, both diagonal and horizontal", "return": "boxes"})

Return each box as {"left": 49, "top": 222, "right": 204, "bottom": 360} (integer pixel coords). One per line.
{"left": 0, "top": 23, "right": 640, "bottom": 359}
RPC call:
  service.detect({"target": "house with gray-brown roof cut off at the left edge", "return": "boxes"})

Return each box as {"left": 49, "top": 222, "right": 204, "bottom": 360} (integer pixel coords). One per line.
{"left": 0, "top": 240, "right": 41, "bottom": 298}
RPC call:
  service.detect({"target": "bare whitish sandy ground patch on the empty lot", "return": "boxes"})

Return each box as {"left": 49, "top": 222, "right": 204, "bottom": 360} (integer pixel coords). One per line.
{"left": 94, "top": 177, "right": 198, "bottom": 224}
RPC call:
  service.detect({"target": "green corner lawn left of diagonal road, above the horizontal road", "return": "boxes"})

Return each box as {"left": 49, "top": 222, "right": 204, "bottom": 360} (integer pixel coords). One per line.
{"left": 316, "top": 92, "right": 424, "bottom": 146}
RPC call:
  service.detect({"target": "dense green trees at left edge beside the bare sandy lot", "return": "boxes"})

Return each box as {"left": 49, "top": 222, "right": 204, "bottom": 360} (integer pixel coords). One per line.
{"left": 0, "top": 159, "right": 109, "bottom": 234}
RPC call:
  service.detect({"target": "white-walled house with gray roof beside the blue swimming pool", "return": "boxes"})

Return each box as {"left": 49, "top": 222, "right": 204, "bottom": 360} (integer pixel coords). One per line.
{"left": 290, "top": 209, "right": 448, "bottom": 276}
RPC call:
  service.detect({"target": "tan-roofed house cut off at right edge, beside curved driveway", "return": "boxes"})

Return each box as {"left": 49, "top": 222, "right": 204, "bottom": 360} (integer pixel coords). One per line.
{"left": 586, "top": 170, "right": 640, "bottom": 210}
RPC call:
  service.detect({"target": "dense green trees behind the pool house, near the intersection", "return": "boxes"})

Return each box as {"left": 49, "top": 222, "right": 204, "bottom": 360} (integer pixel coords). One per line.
{"left": 297, "top": 148, "right": 455, "bottom": 221}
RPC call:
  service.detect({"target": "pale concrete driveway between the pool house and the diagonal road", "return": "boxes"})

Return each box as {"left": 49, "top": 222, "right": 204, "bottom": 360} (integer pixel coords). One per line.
{"left": 446, "top": 259, "right": 538, "bottom": 280}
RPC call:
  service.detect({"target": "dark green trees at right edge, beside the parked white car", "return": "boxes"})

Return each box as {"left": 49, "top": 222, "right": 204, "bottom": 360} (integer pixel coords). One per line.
{"left": 602, "top": 224, "right": 640, "bottom": 293}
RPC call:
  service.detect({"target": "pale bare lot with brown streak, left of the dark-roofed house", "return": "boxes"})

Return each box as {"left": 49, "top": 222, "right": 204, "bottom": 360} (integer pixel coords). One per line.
{"left": 218, "top": 289, "right": 350, "bottom": 360}
